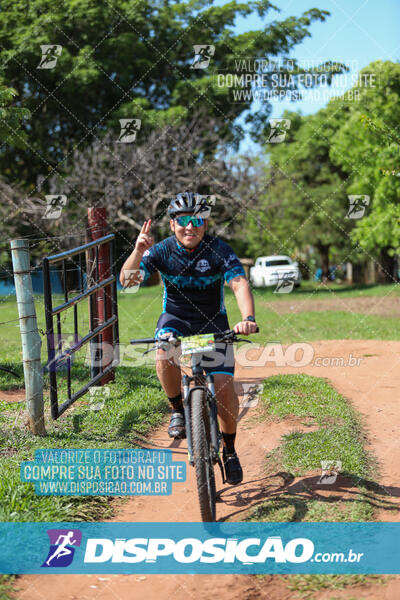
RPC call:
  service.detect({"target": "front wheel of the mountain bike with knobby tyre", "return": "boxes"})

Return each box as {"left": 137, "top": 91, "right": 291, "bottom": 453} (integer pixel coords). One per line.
{"left": 191, "top": 389, "right": 217, "bottom": 522}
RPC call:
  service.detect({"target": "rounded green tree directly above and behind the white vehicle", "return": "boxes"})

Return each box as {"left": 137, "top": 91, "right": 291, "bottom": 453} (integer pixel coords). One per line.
{"left": 245, "top": 103, "right": 353, "bottom": 279}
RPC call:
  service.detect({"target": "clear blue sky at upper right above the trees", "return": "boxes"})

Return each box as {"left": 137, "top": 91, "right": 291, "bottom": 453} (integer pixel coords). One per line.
{"left": 216, "top": 0, "right": 400, "bottom": 151}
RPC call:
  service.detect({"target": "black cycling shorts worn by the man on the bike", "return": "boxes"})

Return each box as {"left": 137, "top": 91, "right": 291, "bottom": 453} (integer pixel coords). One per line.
{"left": 154, "top": 312, "right": 235, "bottom": 376}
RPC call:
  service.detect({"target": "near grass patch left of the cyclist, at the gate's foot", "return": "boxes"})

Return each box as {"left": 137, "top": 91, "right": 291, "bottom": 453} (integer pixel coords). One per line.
{"left": 0, "top": 366, "right": 167, "bottom": 521}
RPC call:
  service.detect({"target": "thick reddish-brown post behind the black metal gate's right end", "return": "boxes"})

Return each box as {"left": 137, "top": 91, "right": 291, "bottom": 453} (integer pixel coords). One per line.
{"left": 88, "top": 208, "right": 115, "bottom": 385}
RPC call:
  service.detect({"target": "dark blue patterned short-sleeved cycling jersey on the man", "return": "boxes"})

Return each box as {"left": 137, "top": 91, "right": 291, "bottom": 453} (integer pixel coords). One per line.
{"left": 140, "top": 234, "right": 245, "bottom": 322}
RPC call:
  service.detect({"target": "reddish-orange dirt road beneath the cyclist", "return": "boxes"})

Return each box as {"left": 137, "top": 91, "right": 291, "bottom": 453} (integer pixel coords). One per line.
{"left": 16, "top": 340, "right": 400, "bottom": 600}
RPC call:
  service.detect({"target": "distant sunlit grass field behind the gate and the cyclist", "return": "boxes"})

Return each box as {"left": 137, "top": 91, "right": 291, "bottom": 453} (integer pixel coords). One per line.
{"left": 0, "top": 282, "right": 400, "bottom": 376}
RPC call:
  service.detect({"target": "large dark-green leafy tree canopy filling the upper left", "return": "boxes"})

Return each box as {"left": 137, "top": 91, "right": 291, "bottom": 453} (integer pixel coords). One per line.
{"left": 0, "top": 0, "right": 329, "bottom": 187}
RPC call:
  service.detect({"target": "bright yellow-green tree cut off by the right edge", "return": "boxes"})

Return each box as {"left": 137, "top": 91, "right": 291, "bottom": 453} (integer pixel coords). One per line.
{"left": 331, "top": 61, "right": 400, "bottom": 282}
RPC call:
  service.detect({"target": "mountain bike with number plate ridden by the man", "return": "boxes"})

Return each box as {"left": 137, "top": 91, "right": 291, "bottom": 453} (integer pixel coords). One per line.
{"left": 131, "top": 328, "right": 259, "bottom": 522}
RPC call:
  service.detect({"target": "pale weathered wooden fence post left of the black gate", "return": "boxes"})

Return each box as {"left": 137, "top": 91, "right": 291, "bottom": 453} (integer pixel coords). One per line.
{"left": 11, "top": 240, "right": 46, "bottom": 435}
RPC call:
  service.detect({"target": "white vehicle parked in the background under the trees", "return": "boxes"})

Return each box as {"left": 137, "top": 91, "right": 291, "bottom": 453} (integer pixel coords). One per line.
{"left": 250, "top": 255, "right": 301, "bottom": 287}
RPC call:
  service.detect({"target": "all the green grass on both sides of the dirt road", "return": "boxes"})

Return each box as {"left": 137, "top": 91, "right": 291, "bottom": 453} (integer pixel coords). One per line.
{"left": 0, "top": 284, "right": 400, "bottom": 598}
